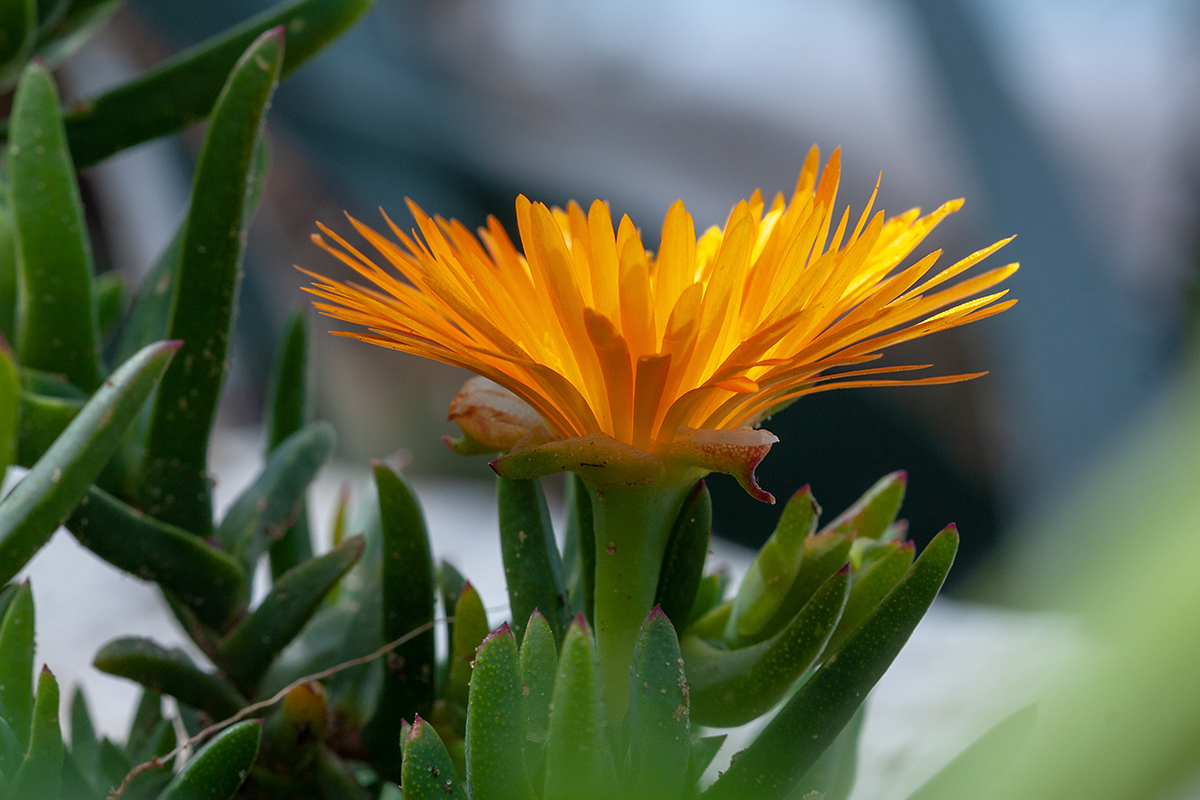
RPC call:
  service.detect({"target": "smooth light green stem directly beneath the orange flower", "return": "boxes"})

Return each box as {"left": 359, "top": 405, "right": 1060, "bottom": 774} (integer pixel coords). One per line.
{"left": 587, "top": 470, "right": 702, "bottom": 724}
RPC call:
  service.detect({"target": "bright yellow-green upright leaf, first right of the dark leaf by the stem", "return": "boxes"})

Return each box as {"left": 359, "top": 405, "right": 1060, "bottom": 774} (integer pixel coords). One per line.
{"left": 725, "top": 486, "right": 821, "bottom": 646}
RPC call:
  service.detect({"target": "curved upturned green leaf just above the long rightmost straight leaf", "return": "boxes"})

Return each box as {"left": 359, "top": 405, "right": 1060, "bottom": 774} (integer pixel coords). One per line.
{"left": 680, "top": 566, "right": 850, "bottom": 728}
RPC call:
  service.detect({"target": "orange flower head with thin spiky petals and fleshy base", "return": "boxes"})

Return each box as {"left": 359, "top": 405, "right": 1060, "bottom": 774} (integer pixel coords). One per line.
{"left": 308, "top": 148, "right": 1016, "bottom": 499}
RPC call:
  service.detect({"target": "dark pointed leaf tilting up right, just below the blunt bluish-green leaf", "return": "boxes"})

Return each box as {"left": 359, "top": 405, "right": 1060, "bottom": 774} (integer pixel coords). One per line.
{"left": 220, "top": 536, "right": 364, "bottom": 697}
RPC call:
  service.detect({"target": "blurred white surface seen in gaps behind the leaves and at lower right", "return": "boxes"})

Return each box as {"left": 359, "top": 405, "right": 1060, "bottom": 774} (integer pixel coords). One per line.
{"left": 8, "top": 434, "right": 1075, "bottom": 800}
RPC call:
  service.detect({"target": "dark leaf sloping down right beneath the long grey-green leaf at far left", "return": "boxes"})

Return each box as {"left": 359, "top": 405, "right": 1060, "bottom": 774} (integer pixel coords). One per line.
{"left": 66, "top": 486, "right": 248, "bottom": 631}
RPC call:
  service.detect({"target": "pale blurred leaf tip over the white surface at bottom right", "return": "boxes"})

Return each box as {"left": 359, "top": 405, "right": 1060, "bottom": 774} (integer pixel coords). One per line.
{"left": 908, "top": 705, "right": 1037, "bottom": 800}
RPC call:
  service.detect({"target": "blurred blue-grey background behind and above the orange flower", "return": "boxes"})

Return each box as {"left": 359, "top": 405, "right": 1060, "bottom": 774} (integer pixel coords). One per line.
{"left": 61, "top": 0, "right": 1200, "bottom": 591}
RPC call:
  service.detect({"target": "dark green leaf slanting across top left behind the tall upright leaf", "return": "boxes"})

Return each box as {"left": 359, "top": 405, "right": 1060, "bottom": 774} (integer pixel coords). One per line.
{"left": 52, "top": 0, "right": 374, "bottom": 168}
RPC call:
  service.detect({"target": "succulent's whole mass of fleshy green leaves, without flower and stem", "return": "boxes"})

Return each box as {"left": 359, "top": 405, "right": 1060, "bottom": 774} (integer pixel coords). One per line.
{"left": 0, "top": 0, "right": 1012, "bottom": 800}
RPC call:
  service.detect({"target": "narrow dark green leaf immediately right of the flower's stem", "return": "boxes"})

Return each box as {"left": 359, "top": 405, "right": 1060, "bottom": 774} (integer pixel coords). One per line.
{"left": 657, "top": 479, "right": 713, "bottom": 630}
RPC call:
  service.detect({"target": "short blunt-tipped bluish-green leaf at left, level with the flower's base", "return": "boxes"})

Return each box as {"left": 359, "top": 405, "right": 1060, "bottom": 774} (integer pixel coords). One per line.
{"left": 216, "top": 422, "right": 336, "bottom": 575}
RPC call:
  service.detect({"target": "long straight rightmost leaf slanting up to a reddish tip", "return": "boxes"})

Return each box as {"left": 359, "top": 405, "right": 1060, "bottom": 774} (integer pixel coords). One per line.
{"left": 703, "top": 525, "right": 959, "bottom": 800}
